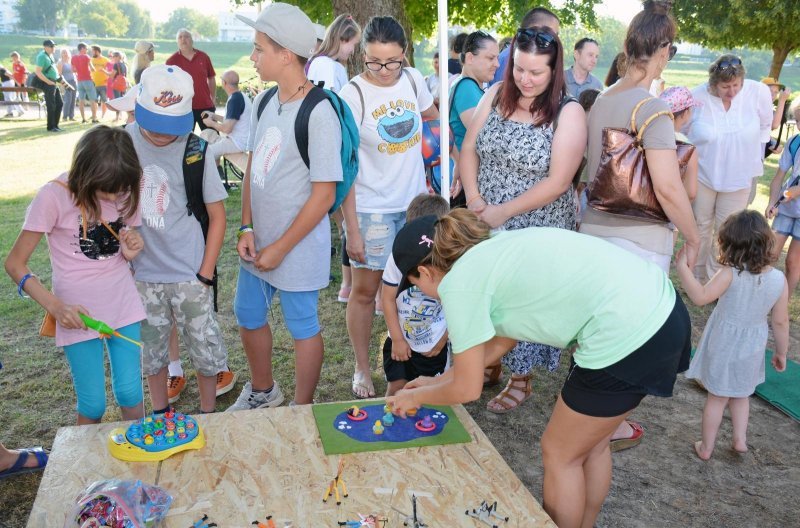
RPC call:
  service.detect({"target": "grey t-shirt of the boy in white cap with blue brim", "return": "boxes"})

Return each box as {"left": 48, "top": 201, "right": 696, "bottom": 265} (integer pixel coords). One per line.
{"left": 125, "top": 123, "right": 228, "bottom": 283}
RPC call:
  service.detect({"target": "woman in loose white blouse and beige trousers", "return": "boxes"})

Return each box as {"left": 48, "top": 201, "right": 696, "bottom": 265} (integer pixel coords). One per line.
{"left": 688, "top": 54, "right": 773, "bottom": 282}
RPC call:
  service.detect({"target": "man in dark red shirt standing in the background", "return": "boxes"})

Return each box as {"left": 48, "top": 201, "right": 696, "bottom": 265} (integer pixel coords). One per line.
{"left": 167, "top": 29, "right": 217, "bottom": 130}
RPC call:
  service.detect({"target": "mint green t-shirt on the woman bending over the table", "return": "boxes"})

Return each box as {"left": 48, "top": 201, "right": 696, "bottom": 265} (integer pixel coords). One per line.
{"left": 439, "top": 227, "right": 675, "bottom": 369}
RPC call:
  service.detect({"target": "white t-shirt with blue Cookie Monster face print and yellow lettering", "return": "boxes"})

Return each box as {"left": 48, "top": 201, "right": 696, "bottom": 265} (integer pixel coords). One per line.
{"left": 339, "top": 68, "right": 433, "bottom": 214}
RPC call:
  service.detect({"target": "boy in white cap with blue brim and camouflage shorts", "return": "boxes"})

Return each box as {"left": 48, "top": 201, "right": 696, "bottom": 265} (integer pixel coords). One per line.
{"left": 125, "top": 65, "right": 228, "bottom": 413}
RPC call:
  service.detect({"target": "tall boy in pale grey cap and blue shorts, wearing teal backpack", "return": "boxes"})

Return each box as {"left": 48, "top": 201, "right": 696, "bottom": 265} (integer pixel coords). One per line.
{"left": 228, "top": 2, "right": 342, "bottom": 411}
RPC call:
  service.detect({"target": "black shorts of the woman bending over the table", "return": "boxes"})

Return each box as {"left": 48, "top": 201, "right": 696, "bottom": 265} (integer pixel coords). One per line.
{"left": 561, "top": 294, "right": 692, "bottom": 418}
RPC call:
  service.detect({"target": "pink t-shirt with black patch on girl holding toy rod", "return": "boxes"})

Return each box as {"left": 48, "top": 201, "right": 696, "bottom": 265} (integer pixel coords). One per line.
{"left": 22, "top": 174, "right": 146, "bottom": 346}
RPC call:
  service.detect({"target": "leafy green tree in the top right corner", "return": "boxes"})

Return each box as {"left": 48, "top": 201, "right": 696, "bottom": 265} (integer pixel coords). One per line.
{"left": 673, "top": 0, "right": 800, "bottom": 79}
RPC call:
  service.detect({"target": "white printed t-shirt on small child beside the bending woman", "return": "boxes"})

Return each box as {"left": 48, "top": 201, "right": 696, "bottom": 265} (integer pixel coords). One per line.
{"left": 383, "top": 255, "right": 447, "bottom": 353}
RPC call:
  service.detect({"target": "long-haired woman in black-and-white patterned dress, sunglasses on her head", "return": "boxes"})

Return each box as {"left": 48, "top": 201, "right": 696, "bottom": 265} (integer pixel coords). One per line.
{"left": 459, "top": 26, "right": 586, "bottom": 413}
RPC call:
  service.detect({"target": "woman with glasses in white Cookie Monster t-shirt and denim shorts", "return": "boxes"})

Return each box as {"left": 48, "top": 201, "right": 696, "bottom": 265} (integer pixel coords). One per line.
{"left": 339, "top": 17, "right": 439, "bottom": 398}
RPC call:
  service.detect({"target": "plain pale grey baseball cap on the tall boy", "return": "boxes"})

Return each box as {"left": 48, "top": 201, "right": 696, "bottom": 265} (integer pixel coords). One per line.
{"left": 236, "top": 2, "right": 317, "bottom": 59}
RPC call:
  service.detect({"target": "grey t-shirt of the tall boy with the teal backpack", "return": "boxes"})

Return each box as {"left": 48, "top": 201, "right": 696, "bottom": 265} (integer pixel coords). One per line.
{"left": 242, "top": 88, "right": 342, "bottom": 291}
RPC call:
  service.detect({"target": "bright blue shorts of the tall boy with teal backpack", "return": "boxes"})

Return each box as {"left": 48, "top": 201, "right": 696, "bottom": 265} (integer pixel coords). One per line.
{"left": 233, "top": 267, "right": 320, "bottom": 339}
